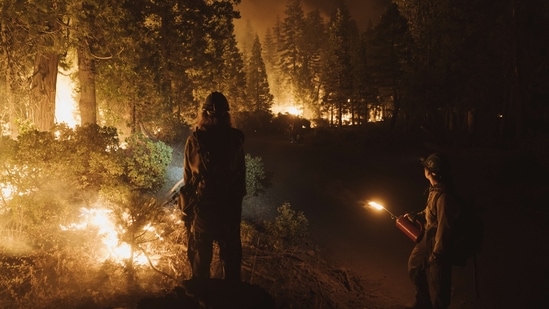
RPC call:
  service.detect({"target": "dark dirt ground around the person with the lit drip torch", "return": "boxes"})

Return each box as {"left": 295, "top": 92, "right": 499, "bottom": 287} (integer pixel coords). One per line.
{"left": 244, "top": 128, "right": 549, "bottom": 309}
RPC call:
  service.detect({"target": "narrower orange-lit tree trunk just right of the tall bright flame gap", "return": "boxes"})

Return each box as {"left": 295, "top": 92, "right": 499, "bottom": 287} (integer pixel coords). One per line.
{"left": 78, "top": 46, "right": 97, "bottom": 125}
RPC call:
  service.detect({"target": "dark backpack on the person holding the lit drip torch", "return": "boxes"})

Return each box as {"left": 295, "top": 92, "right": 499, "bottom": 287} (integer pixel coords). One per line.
{"left": 450, "top": 199, "right": 484, "bottom": 266}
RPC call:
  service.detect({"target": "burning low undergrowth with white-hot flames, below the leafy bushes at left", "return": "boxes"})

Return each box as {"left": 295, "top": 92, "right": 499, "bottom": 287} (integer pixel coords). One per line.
{"left": 0, "top": 196, "right": 188, "bottom": 308}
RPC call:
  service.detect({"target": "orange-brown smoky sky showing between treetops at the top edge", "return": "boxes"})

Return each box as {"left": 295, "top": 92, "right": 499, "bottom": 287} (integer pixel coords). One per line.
{"left": 236, "top": 0, "right": 387, "bottom": 36}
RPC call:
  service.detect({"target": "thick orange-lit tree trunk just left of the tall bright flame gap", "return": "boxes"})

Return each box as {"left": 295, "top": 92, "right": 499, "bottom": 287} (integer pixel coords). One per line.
{"left": 31, "top": 52, "right": 59, "bottom": 131}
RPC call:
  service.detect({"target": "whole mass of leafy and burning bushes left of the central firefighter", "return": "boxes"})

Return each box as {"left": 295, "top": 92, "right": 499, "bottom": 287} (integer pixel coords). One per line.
{"left": 0, "top": 125, "right": 186, "bottom": 307}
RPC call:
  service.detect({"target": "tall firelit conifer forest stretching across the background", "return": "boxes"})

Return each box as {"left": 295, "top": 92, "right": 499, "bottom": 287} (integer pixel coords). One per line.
{"left": 0, "top": 0, "right": 549, "bottom": 142}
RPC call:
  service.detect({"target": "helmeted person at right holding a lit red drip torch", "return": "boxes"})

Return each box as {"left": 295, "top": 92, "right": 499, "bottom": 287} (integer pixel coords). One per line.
{"left": 407, "top": 153, "right": 459, "bottom": 309}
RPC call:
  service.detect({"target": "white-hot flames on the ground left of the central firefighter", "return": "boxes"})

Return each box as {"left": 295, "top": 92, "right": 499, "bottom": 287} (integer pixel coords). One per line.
{"left": 61, "top": 208, "right": 160, "bottom": 265}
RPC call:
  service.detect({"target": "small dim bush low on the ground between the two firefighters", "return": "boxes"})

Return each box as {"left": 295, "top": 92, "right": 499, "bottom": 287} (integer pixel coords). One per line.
{"left": 265, "top": 203, "right": 309, "bottom": 250}
